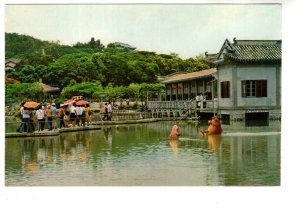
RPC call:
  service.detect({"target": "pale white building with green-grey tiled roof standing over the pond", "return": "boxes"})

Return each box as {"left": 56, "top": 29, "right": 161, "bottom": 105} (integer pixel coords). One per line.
{"left": 214, "top": 39, "right": 281, "bottom": 120}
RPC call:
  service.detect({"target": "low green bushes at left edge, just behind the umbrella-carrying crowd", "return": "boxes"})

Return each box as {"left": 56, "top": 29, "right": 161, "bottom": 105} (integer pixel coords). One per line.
{"left": 5, "top": 82, "right": 44, "bottom": 101}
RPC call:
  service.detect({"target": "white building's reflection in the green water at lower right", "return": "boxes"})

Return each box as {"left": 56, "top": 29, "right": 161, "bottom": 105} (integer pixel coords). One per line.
{"left": 217, "top": 135, "right": 280, "bottom": 186}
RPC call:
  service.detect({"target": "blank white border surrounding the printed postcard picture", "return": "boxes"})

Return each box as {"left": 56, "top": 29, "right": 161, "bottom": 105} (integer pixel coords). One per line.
{"left": 0, "top": 0, "right": 300, "bottom": 214}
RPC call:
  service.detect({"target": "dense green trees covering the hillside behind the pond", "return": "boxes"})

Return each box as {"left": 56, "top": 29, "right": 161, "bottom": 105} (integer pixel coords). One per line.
{"left": 5, "top": 33, "right": 210, "bottom": 91}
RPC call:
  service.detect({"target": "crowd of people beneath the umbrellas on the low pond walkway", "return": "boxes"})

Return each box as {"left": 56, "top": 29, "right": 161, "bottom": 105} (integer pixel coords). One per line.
{"left": 17, "top": 103, "right": 92, "bottom": 132}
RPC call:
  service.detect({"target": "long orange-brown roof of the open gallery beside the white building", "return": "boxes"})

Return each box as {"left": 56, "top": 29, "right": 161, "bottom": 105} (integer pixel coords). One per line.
{"left": 162, "top": 68, "right": 217, "bottom": 83}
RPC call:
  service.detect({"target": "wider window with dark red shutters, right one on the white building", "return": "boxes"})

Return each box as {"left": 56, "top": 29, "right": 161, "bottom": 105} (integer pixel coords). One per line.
{"left": 242, "top": 80, "right": 267, "bottom": 97}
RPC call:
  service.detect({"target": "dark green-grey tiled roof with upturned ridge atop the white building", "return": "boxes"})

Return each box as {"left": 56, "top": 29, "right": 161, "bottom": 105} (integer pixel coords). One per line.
{"left": 219, "top": 40, "right": 281, "bottom": 62}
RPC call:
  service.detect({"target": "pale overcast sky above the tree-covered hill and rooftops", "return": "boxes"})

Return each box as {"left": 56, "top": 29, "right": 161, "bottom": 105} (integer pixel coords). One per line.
{"left": 5, "top": 4, "right": 282, "bottom": 58}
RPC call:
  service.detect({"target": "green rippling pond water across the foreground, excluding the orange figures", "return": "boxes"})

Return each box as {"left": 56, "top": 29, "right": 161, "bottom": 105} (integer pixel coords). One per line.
{"left": 5, "top": 121, "right": 281, "bottom": 186}
